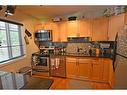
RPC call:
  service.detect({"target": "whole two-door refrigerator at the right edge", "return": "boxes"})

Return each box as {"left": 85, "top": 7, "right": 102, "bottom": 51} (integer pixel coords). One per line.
{"left": 113, "top": 26, "right": 127, "bottom": 89}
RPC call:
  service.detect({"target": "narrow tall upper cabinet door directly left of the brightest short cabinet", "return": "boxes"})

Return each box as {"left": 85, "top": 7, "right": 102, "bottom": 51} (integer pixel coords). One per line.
{"left": 59, "top": 21, "right": 67, "bottom": 42}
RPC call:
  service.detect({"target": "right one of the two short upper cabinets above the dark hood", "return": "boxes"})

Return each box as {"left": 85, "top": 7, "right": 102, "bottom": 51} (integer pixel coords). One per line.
{"left": 78, "top": 19, "right": 92, "bottom": 37}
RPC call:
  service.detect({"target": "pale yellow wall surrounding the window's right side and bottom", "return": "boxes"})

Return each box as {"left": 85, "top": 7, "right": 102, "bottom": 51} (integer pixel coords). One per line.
{"left": 0, "top": 19, "right": 38, "bottom": 72}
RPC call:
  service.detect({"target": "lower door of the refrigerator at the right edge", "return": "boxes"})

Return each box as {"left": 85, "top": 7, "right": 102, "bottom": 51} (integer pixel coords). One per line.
{"left": 113, "top": 55, "right": 127, "bottom": 89}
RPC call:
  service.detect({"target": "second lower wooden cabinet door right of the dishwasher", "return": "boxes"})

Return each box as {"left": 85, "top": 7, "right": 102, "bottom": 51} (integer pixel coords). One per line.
{"left": 78, "top": 59, "right": 91, "bottom": 80}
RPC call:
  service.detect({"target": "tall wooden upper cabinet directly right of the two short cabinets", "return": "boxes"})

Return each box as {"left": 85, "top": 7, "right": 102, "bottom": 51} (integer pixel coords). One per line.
{"left": 92, "top": 17, "right": 109, "bottom": 41}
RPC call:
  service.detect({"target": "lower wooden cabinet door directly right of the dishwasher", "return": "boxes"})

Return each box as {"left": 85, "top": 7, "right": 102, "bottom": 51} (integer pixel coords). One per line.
{"left": 66, "top": 58, "right": 78, "bottom": 78}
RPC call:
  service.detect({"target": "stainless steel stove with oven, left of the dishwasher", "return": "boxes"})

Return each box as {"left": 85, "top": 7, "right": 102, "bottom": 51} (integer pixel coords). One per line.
{"left": 32, "top": 47, "right": 54, "bottom": 71}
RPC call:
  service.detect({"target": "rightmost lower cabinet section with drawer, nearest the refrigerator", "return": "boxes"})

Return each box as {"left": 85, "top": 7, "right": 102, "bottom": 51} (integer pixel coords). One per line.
{"left": 91, "top": 58, "right": 112, "bottom": 82}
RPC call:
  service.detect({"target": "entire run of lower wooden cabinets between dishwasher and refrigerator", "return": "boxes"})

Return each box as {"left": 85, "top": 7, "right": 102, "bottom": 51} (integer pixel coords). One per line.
{"left": 66, "top": 57, "right": 112, "bottom": 82}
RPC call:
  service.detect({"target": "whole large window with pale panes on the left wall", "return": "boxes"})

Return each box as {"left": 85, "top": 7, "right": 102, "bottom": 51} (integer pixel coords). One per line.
{"left": 0, "top": 21, "right": 24, "bottom": 63}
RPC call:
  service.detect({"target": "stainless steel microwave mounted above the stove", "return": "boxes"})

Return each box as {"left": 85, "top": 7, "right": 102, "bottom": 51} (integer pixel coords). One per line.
{"left": 35, "top": 30, "right": 52, "bottom": 41}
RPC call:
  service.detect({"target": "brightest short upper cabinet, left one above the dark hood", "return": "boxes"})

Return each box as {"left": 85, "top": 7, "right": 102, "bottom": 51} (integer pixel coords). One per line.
{"left": 67, "top": 20, "right": 79, "bottom": 37}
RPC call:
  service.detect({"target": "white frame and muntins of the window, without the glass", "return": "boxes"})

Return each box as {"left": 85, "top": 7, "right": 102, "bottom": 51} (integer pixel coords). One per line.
{"left": 0, "top": 20, "right": 25, "bottom": 65}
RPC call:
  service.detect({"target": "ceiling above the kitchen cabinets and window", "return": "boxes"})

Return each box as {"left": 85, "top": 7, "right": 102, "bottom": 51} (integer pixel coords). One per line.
{"left": 0, "top": 5, "right": 112, "bottom": 21}
